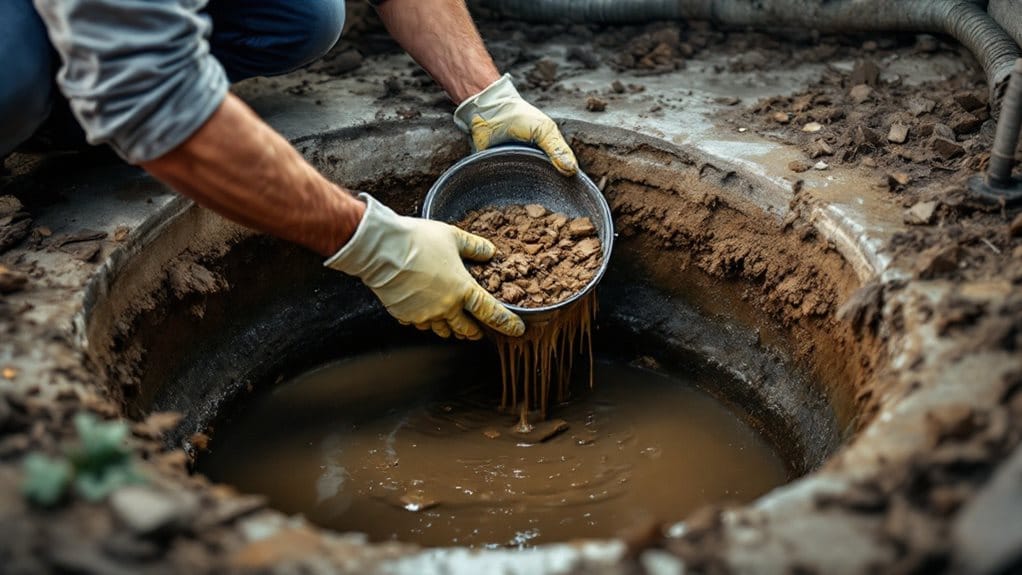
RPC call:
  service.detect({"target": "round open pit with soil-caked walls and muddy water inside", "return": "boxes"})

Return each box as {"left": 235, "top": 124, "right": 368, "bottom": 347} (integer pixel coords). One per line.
{"left": 75, "top": 125, "right": 878, "bottom": 567}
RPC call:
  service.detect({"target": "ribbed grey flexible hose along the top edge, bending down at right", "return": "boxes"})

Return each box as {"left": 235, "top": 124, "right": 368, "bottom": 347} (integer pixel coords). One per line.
{"left": 476, "top": 0, "right": 1022, "bottom": 113}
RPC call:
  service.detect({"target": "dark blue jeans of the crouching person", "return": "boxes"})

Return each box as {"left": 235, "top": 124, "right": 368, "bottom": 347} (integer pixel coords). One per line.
{"left": 0, "top": 0, "right": 344, "bottom": 158}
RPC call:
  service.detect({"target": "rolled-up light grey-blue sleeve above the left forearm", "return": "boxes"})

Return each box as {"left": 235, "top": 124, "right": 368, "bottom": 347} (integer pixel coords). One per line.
{"left": 34, "top": 0, "right": 229, "bottom": 163}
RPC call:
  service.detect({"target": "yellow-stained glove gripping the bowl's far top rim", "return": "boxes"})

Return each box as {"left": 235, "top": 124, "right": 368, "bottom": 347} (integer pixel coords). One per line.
{"left": 454, "top": 74, "right": 578, "bottom": 176}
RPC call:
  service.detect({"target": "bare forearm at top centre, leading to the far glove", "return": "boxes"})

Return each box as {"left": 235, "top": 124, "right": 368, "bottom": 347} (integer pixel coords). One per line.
{"left": 378, "top": 0, "right": 500, "bottom": 104}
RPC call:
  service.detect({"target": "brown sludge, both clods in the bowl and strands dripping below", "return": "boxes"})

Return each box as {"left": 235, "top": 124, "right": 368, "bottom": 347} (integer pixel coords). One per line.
{"left": 458, "top": 203, "right": 603, "bottom": 433}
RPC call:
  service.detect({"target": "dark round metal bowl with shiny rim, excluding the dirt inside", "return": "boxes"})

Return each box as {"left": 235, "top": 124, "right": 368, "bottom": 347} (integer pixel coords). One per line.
{"left": 422, "top": 145, "right": 614, "bottom": 323}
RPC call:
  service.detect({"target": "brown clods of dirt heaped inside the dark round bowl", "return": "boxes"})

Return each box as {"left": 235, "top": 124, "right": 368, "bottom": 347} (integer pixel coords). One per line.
{"left": 457, "top": 204, "right": 603, "bottom": 307}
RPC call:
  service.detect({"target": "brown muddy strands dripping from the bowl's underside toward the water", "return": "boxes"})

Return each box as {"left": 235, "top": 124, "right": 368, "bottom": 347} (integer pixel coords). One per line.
{"left": 494, "top": 292, "right": 597, "bottom": 433}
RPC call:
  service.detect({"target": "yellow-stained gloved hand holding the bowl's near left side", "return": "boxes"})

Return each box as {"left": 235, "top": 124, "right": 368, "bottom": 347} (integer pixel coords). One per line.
{"left": 324, "top": 194, "right": 525, "bottom": 339}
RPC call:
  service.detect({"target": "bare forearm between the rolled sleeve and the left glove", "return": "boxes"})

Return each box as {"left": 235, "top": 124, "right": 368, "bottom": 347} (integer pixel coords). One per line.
{"left": 142, "top": 94, "right": 365, "bottom": 255}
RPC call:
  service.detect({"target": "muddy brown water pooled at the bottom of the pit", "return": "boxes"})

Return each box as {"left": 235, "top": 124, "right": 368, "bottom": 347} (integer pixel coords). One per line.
{"left": 198, "top": 344, "right": 789, "bottom": 547}
